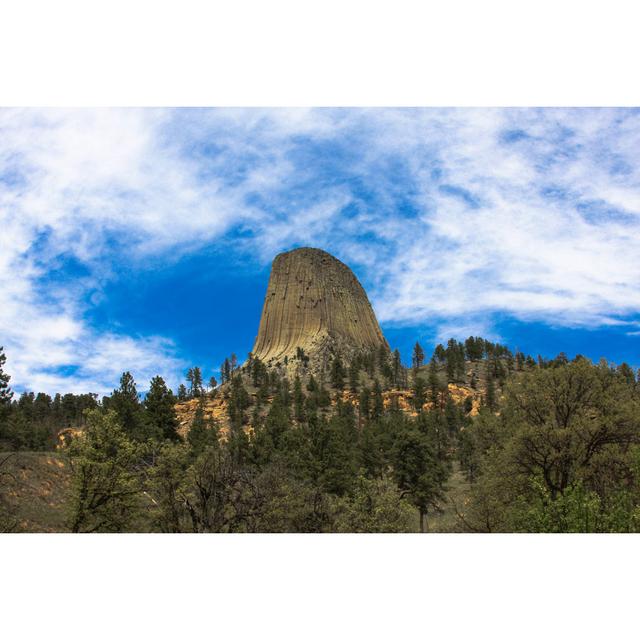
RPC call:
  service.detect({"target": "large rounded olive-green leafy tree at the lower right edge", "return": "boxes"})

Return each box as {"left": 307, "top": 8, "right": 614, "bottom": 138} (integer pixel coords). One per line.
{"left": 461, "top": 358, "right": 640, "bottom": 532}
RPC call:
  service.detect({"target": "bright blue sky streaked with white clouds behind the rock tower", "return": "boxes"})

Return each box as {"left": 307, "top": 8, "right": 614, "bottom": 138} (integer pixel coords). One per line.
{"left": 0, "top": 109, "right": 640, "bottom": 393}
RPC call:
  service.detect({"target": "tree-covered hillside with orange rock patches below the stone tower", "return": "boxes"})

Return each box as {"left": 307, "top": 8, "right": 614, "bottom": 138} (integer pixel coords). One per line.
{"left": 0, "top": 337, "right": 640, "bottom": 532}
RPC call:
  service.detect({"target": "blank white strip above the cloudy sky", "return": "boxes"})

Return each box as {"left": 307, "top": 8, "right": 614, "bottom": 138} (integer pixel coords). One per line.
{"left": 0, "top": 0, "right": 640, "bottom": 106}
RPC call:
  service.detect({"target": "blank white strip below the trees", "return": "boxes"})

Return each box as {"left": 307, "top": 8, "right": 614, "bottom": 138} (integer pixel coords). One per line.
{"left": 0, "top": 534, "right": 640, "bottom": 640}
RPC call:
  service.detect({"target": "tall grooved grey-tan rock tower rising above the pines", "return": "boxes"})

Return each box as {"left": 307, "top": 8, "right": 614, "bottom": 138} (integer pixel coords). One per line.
{"left": 253, "top": 248, "right": 389, "bottom": 369}
